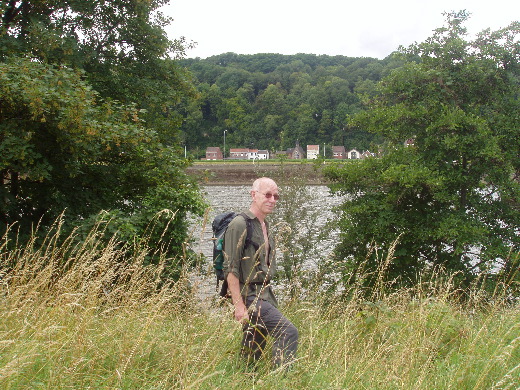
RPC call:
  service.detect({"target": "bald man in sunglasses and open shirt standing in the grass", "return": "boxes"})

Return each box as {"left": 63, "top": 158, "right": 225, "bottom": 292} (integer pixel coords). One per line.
{"left": 224, "top": 177, "right": 298, "bottom": 366}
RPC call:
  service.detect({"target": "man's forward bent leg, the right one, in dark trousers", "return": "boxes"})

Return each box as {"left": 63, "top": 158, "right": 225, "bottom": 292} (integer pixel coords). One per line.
{"left": 248, "top": 300, "right": 298, "bottom": 366}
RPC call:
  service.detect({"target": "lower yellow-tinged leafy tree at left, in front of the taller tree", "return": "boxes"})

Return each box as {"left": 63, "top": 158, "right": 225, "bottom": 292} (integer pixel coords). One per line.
{"left": 0, "top": 59, "right": 202, "bottom": 258}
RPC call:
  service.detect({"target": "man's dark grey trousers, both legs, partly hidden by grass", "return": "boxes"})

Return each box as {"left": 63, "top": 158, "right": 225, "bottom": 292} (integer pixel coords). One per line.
{"left": 242, "top": 297, "right": 298, "bottom": 366}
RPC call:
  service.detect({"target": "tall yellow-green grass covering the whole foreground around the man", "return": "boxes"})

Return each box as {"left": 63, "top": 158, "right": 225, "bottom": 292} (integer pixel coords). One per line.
{"left": 0, "top": 215, "right": 520, "bottom": 390}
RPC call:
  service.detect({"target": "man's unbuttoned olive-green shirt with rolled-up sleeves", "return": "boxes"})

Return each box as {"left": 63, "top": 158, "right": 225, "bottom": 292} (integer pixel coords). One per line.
{"left": 224, "top": 211, "right": 277, "bottom": 306}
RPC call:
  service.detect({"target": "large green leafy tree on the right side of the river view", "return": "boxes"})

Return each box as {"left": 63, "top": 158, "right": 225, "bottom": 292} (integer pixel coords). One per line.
{"left": 327, "top": 12, "right": 520, "bottom": 292}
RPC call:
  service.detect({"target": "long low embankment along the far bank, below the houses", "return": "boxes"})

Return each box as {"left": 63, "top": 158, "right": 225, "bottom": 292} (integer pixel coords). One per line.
{"left": 187, "top": 161, "right": 326, "bottom": 185}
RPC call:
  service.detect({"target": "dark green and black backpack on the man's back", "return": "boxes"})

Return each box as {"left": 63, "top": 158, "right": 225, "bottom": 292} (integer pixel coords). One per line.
{"left": 211, "top": 211, "right": 259, "bottom": 297}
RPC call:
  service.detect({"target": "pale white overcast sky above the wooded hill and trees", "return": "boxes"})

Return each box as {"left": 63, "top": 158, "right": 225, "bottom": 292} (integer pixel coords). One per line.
{"left": 162, "top": 0, "right": 520, "bottom": 59}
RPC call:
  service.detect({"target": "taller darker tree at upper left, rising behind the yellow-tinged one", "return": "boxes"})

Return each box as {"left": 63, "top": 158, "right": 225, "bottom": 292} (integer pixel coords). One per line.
{"left": 0, "top": 0, "right": 194, "bottom": 145}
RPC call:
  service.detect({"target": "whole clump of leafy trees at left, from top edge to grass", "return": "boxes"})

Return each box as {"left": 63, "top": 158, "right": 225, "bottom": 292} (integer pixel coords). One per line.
{"left": 0, "top": 0, "right": 203, "bottom": 274}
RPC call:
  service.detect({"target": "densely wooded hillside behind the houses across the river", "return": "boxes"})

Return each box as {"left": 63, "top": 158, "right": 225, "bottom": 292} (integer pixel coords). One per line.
{"left": 180, "top": 53, "right": 401, "bottom": 157}
